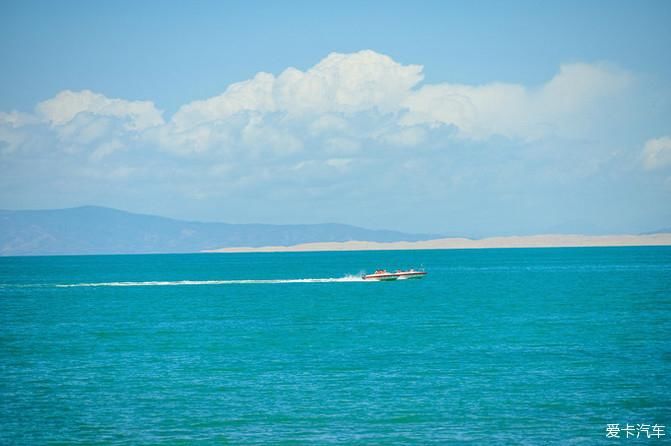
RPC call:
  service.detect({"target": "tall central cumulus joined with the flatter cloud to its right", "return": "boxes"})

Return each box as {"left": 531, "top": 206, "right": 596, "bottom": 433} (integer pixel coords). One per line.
{"left": 163, "top": 51, "right": 631, "bottom": 153}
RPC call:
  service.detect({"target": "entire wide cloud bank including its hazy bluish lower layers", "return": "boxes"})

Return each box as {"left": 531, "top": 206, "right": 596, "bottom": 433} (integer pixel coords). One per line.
{"left": 0, "top": 50, "right": 671, "bottom": 233}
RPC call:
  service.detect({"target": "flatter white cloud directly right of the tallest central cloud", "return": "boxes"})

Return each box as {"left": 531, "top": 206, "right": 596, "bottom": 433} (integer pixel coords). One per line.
{"left": 401, "top": 64, "right": 630, "bottom": 140}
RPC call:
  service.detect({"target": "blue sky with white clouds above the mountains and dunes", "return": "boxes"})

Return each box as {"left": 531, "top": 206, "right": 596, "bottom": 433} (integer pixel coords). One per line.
{"left": 0, "top": 1, "right": 671, "bottom": 237}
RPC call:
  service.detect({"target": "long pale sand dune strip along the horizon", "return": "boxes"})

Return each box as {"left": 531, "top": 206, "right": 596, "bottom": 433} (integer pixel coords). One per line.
{"left": 204, "top": 233, "right": 671, "bottom": 252}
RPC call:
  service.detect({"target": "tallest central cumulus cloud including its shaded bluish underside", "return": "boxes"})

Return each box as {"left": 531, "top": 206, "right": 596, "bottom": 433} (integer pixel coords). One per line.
{"left": 155, "top": 51, "right": 423, "bottom": 154}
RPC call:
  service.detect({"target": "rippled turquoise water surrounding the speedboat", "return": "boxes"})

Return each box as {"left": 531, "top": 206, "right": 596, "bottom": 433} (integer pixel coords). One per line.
{"left": 0, "top": 248, "right": 671, "bottom": 444}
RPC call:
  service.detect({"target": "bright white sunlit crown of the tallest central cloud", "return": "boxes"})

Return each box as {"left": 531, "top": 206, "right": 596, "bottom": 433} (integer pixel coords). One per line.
{"left": 171, "top": 50, "right": 423, "bottom": 146}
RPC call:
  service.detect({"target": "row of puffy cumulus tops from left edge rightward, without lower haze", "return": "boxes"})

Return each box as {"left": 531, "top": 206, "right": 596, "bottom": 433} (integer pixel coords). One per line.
{"left": 0, "top": 50, "right": 631, "bottom": 159}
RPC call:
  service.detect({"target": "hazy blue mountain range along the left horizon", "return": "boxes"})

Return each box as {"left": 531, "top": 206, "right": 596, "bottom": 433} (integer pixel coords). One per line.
{"left": 0, "top": 206, "right": 440, "bottom": 256}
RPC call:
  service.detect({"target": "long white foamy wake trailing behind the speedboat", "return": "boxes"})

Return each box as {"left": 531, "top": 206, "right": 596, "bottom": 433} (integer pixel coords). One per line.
{"left": 56, "top": 276, "right": 373, "bottom": 288}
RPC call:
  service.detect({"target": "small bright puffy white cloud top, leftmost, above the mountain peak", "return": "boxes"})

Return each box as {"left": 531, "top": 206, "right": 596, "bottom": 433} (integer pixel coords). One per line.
{"left": 36, "top": 90, "right": 164, "bottom": 131}
